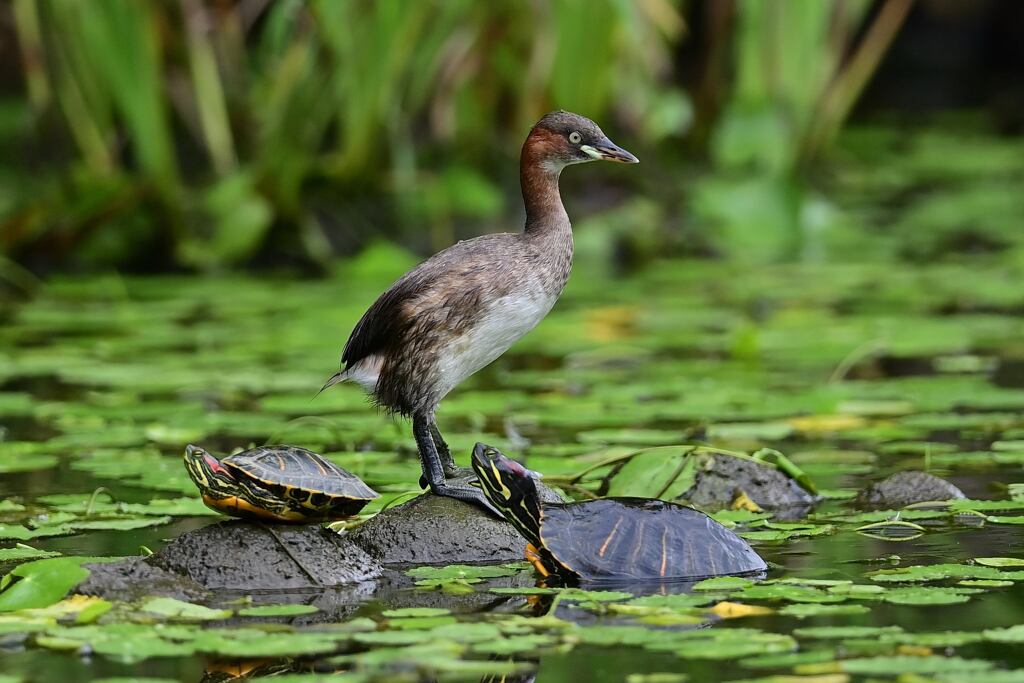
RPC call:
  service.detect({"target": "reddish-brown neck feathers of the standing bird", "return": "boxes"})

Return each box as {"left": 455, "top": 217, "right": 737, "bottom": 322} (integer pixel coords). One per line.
{"left": 519, "top": 128, "right": 569, "bottom": 236}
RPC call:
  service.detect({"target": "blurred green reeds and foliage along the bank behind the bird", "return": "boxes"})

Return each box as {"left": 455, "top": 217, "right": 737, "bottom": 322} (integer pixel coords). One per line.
{"left": 0, "top": 0, "right": 1021, "bottom": 272}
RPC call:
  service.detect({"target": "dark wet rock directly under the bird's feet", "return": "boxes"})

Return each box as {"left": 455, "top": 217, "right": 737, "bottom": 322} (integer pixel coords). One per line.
{"left": 349, "top": 485, "right": 563, "bottom": 565}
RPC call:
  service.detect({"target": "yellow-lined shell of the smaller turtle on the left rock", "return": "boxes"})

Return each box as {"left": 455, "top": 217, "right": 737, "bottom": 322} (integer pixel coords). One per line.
{"left": 220, "top": 445, "right": 379, "bottom": 514}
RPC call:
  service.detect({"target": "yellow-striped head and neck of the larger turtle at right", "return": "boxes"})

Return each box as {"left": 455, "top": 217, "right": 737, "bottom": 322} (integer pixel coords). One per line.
{"left": 472, "top": 443, "right": 541, "bottom": 545}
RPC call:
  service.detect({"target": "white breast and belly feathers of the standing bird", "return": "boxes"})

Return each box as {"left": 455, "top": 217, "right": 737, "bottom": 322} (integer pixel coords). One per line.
{"left": 435, "top": 287, "right": 558, "bottom": 397}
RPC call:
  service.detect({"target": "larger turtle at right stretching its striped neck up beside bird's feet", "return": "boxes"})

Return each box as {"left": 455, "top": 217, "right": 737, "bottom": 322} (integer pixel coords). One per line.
{"left": 473, "top": 443, "right": 767, "bottom": 581}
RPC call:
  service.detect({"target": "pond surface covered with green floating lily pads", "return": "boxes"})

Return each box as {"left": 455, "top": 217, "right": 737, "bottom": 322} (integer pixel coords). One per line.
{"left": 0, "top": 248, "right": 1024, "bottom": 683}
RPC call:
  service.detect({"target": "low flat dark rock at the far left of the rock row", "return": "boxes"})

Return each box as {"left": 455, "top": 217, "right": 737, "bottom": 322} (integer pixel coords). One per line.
{"left": 74, "top": 557, "right": 209, "bottom": 602}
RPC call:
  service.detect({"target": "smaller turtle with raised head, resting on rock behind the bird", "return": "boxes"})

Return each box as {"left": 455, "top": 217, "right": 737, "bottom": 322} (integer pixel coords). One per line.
{"left": 184, "top": 445, "right": 379, "bottom": 522}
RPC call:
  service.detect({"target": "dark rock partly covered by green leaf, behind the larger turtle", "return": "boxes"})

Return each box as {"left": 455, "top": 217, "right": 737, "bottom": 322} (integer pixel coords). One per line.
{"left": 680, "top": 455, "right": 817, "bottom": 516}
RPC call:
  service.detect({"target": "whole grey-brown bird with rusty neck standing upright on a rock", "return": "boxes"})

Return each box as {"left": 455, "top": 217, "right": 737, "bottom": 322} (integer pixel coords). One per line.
{"left": 325, "top": 112, "right": 637, "bottom": 510}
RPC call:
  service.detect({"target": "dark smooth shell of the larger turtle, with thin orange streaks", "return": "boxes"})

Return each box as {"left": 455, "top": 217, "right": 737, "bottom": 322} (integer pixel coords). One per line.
{"left": 541, "top": 498, "right": 767, "bottom": 581}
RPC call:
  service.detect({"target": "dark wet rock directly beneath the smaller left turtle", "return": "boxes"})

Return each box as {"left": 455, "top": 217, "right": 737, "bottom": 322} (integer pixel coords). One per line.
{"left": 147, "top": 521, "right": 382, "bottom": 590}
